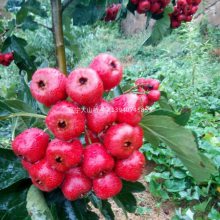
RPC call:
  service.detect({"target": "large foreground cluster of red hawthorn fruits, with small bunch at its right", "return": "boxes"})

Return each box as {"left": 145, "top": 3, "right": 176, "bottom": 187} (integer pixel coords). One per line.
{"left": 12, "top": 54, "right": 159, "bottom": 200}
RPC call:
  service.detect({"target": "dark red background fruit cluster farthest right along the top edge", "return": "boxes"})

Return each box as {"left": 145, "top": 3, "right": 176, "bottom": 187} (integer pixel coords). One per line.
{"left": 170, "top": 0, "right": 201, "bottom": 28}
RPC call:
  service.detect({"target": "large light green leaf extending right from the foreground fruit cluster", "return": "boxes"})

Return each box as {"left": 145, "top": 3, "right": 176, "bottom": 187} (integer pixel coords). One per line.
{"left": 141, "top": 115, "right": 217, "bottom": 183}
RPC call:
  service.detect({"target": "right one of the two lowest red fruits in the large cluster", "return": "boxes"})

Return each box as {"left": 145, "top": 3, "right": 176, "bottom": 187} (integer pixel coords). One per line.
{"left": 93, "top": 172, "right": 122, "bottom": 199}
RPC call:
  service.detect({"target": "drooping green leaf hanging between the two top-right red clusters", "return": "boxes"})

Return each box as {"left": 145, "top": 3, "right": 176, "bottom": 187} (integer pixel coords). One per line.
{"left": 143, "top": 6, "right": 173, "bottom": 46}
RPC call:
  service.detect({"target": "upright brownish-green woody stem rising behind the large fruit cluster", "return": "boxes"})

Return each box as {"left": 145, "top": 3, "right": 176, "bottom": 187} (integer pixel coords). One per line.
{"left": 50, "top": 0, "right": 67, "bottom": 75}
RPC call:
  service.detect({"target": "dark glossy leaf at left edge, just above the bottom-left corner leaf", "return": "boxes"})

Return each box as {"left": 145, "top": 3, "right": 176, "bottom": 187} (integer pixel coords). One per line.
{"left": 0, "top": 148, "right": 28, "bottom": 190}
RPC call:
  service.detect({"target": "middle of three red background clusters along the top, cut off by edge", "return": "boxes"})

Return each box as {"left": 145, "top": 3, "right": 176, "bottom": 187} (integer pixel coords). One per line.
{"left": 130, "top": 0, "right": 170, "bottom": 14}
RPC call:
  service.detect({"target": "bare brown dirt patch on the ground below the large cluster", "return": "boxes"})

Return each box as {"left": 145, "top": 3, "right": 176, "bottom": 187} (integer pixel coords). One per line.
{"left": 91, "top": 162, "right": 174, "bottom": 220}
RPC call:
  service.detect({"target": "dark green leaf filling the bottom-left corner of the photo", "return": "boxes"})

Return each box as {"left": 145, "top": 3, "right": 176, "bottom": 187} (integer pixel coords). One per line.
{"left": 0, "top": 185, "right": 31, "bottom": 220}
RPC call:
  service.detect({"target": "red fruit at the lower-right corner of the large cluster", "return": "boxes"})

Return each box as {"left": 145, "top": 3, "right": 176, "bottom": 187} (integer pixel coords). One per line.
{"left": 115, "top": 151, "right": 145, "bottom": 182}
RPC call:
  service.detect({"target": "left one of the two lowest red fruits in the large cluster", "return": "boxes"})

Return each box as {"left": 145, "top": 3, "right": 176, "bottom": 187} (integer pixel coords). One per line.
{"left": 61, "top": 167, "right": 92, "bottom": 200}
